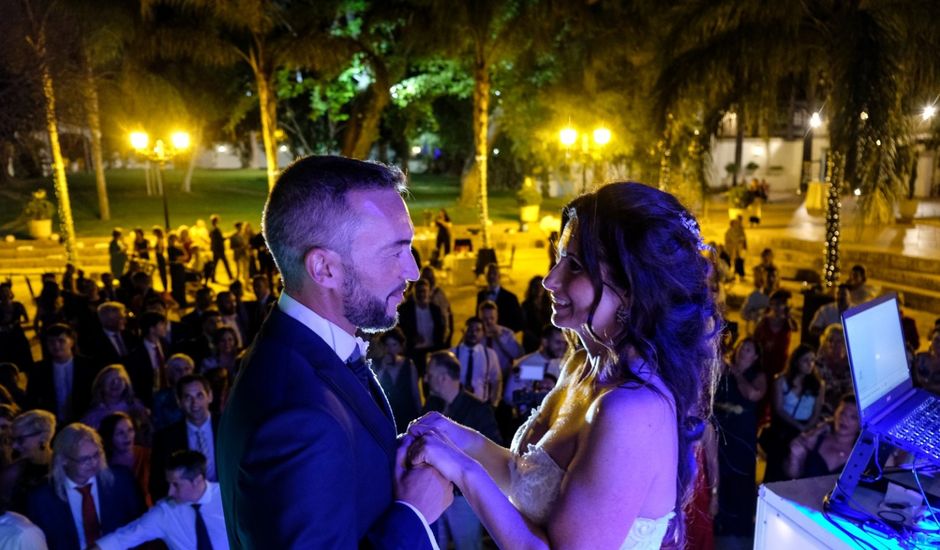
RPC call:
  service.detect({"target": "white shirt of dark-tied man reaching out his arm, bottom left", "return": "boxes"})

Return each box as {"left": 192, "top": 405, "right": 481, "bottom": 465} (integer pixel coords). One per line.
{"left": 98, "top": 481, "right": 229, "bottom": 550}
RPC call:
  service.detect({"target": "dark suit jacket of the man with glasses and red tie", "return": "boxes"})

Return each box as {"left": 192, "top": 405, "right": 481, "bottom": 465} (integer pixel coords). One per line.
{"left": 26, "top": 466, "right": 146, "bottom": 550}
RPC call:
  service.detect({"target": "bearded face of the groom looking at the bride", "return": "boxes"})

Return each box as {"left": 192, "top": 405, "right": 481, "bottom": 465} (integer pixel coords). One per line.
{"left": 343, "top": 190, "right": 418, "bottom": 332}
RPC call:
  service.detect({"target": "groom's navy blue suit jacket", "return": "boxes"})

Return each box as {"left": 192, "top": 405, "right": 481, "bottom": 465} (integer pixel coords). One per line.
{"left": 216, "top": 306, "right": 431, "bottom": 549}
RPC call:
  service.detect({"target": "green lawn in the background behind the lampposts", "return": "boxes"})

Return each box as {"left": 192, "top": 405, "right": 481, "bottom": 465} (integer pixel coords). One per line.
{"left": 0, "top": 170, "right": 564, "bottom": 237}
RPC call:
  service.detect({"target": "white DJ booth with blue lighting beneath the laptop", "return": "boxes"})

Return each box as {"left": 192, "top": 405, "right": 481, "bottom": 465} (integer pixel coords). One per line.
{"left": 754, "top": 472, "right": 940, "bottom": 550}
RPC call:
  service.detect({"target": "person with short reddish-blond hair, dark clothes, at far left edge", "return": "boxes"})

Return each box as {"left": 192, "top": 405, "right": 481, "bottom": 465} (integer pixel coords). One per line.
{"left": 0, "top": 410, "right": 56, "bottom": 512}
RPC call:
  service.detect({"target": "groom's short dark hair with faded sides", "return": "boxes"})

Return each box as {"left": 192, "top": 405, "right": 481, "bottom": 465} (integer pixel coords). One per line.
{"left": 261, "top": 156, "right": 406, "bottom": 292}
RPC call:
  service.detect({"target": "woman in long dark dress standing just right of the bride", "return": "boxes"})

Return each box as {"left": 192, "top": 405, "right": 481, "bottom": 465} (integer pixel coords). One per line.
{"left": 712, "top": 337, "right": 767, "bottom": 538}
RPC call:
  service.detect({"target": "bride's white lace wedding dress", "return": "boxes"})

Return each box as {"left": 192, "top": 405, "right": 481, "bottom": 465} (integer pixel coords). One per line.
{"left": 509, "top": 409, "right": 675, "bottom": 550}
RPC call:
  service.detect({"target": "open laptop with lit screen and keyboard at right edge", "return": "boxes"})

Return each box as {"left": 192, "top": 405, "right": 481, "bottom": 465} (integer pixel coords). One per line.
{"left": 842, "top": 293, "right": 940, "bottom": 465}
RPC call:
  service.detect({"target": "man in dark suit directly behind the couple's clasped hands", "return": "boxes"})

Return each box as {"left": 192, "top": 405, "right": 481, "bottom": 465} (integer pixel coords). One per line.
{"left": 424, "top": 351, "right": 502, "bottom": 550}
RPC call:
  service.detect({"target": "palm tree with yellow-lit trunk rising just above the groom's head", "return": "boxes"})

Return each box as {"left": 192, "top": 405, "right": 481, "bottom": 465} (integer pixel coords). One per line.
{"left": 142, "top": 0, "right": 353, "bottom": 192}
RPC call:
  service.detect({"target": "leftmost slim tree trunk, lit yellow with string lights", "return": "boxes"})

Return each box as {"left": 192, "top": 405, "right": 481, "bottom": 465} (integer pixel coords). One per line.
{"left": 35, "top": 40, "right": 78, "bottom": 264}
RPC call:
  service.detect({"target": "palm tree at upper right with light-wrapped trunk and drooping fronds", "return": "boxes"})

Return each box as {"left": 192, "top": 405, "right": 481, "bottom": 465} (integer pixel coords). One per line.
{"left": 657, "top": 0, "right": 940, "bottom": 286}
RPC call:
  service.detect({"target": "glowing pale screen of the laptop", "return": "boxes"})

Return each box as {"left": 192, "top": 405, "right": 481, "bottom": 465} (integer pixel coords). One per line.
{"left": 842, "top": 295, "right": 910, "bottom": 411}
